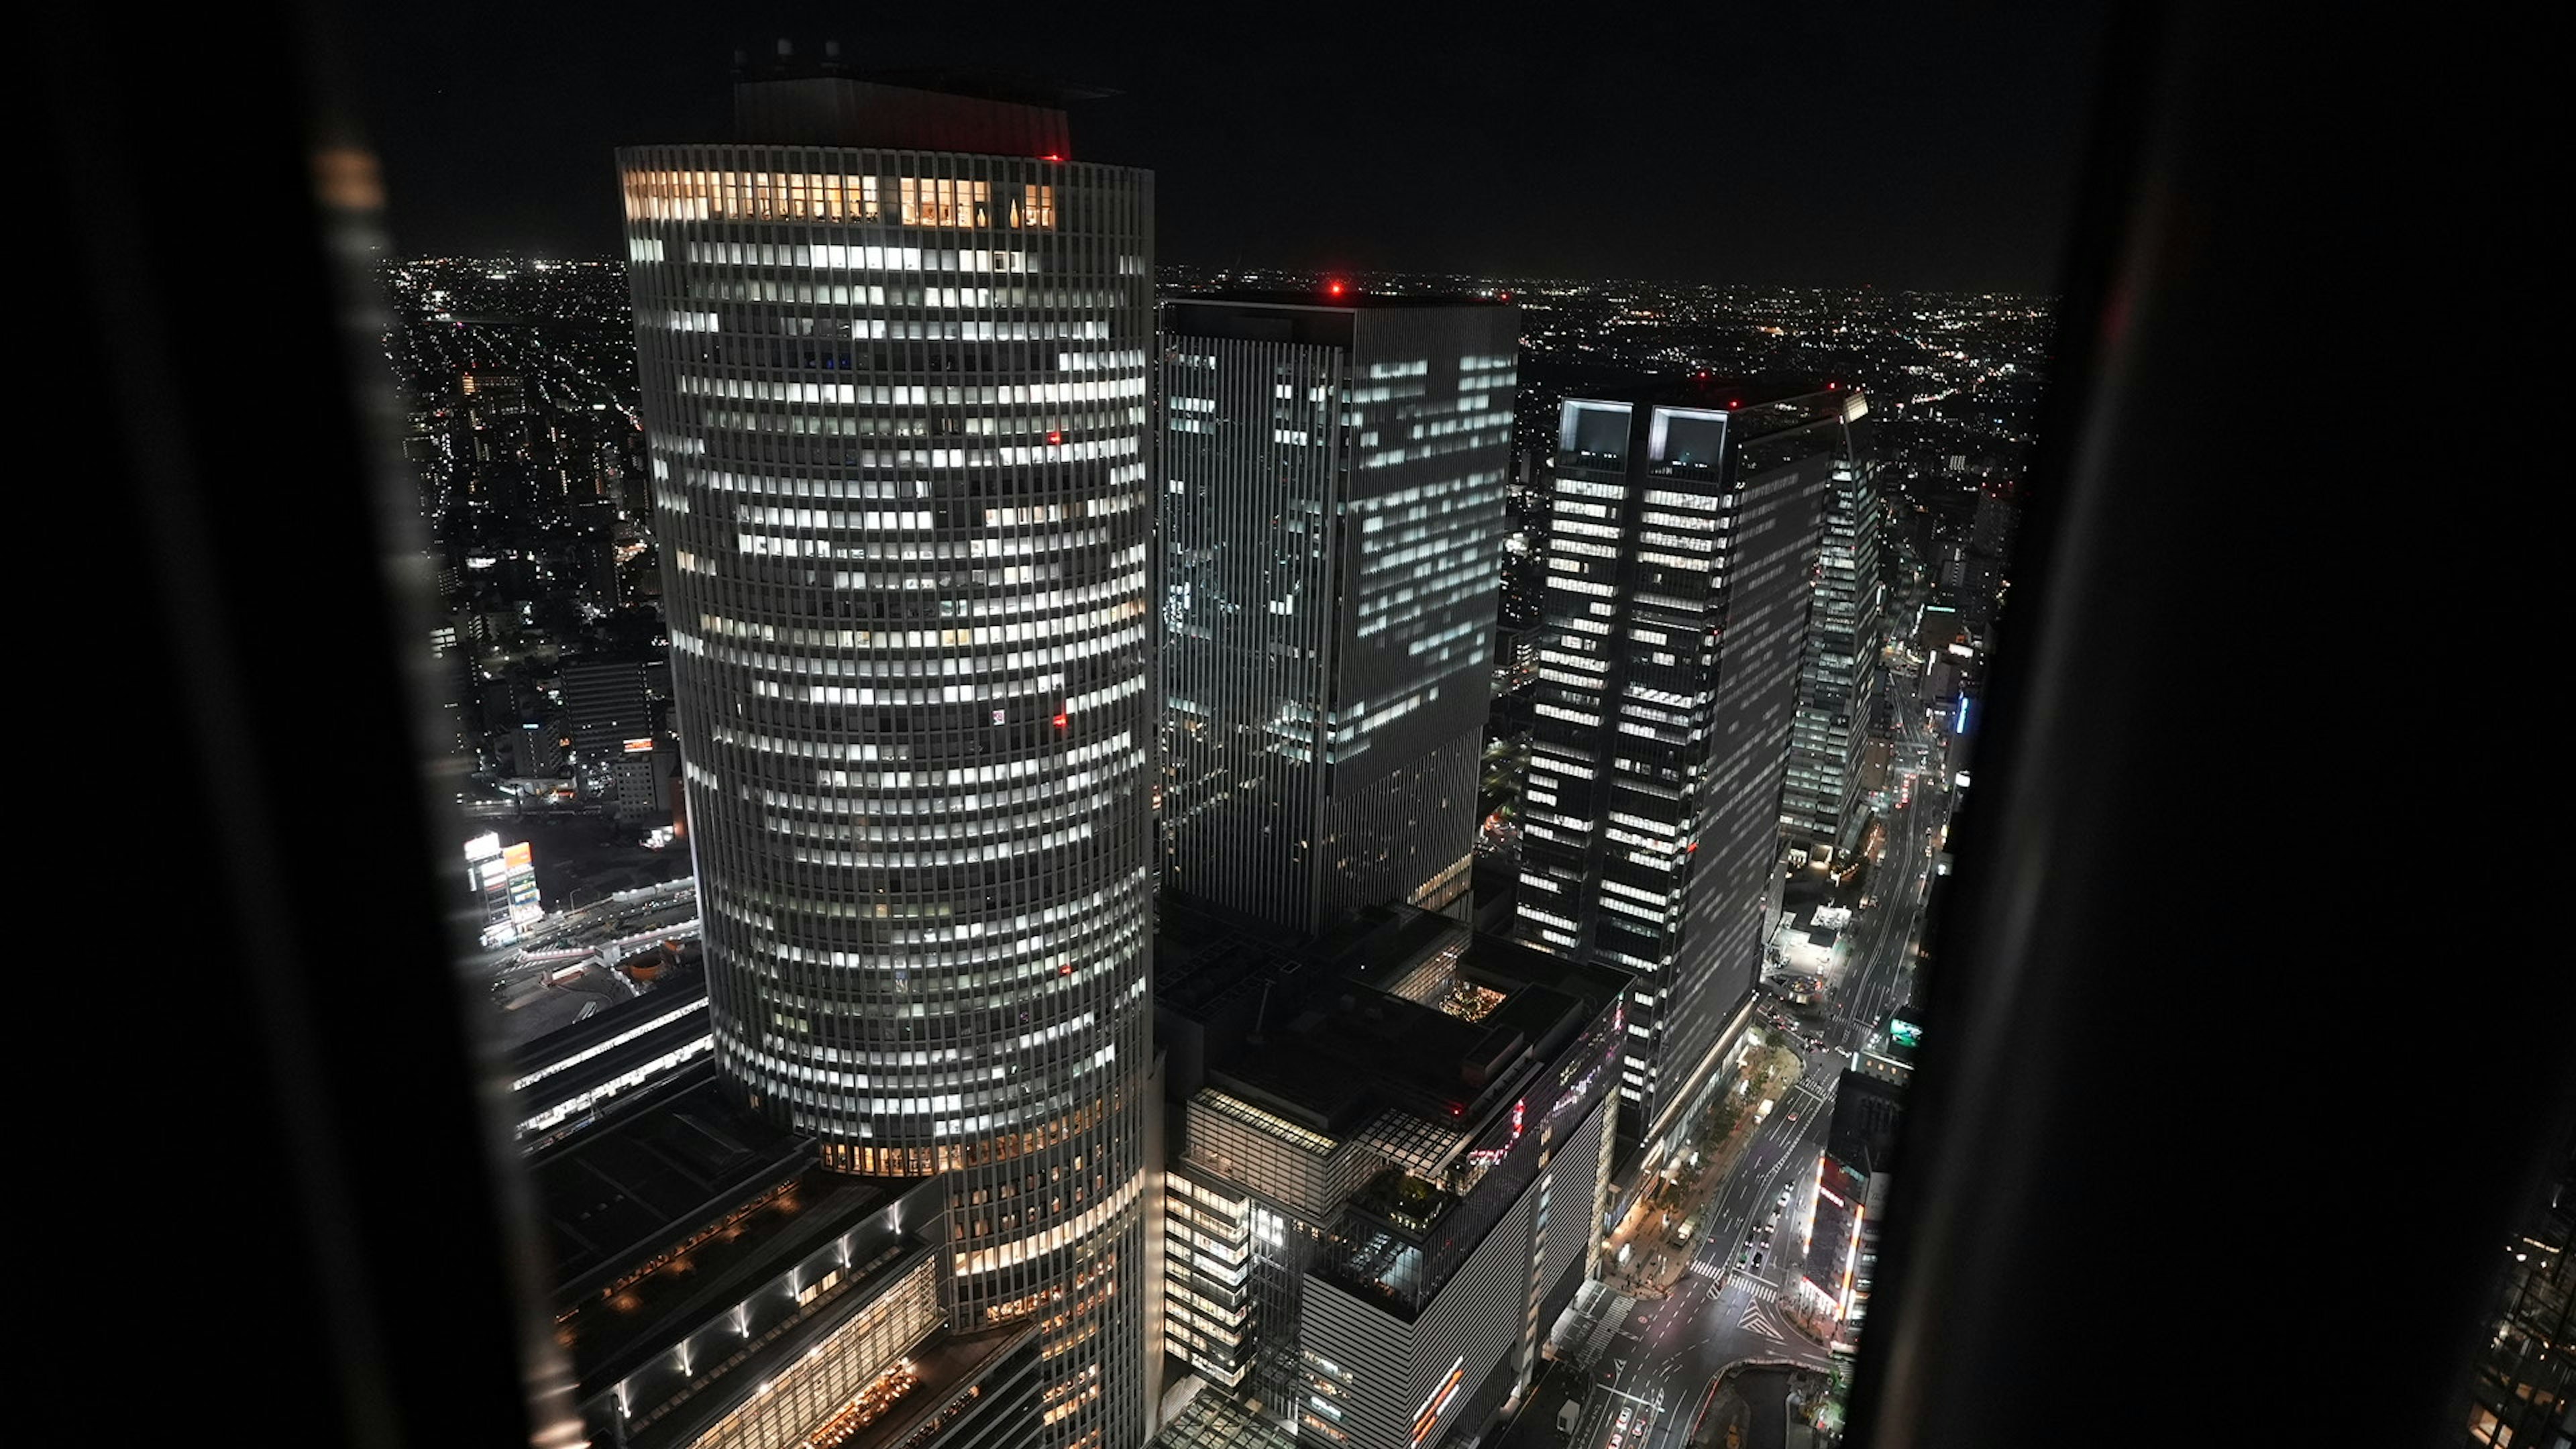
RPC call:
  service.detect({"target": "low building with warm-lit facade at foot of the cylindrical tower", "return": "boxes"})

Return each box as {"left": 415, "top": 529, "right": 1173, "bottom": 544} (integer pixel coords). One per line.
{"left": 528, "top": 1062, "right": 1054, "bottom": 1449}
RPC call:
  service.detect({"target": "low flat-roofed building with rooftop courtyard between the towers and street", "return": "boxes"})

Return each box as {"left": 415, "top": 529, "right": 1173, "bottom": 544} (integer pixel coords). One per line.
{"left": 1157, "top": 908, "right": 1628, "bottom": 1449}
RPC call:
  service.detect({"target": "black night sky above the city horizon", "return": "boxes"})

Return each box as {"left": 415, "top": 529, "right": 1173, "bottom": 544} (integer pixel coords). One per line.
{"left": 350, "top": 0, "right": 2102, "bottom": 291}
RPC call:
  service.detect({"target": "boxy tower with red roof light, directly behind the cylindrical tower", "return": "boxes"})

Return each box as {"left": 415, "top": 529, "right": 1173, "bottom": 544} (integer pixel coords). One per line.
{"left": 1157, "top": 297, "right": 1520, "bottom": 933}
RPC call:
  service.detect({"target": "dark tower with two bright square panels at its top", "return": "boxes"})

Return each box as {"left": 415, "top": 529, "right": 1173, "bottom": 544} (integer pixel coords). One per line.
{"left": 1520, "top": 382, "right": 1865, "bottom": 1142}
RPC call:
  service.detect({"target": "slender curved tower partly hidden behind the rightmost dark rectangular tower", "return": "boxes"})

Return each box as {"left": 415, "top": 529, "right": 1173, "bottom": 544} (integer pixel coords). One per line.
{"left": 1780, "top": 451, "right": 1886, "bottom": 856}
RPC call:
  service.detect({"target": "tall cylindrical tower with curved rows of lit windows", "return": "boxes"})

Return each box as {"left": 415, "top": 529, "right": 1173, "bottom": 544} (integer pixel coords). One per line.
{"left": 619, "top": 56, "right": 1154, "bottom": 1449}
